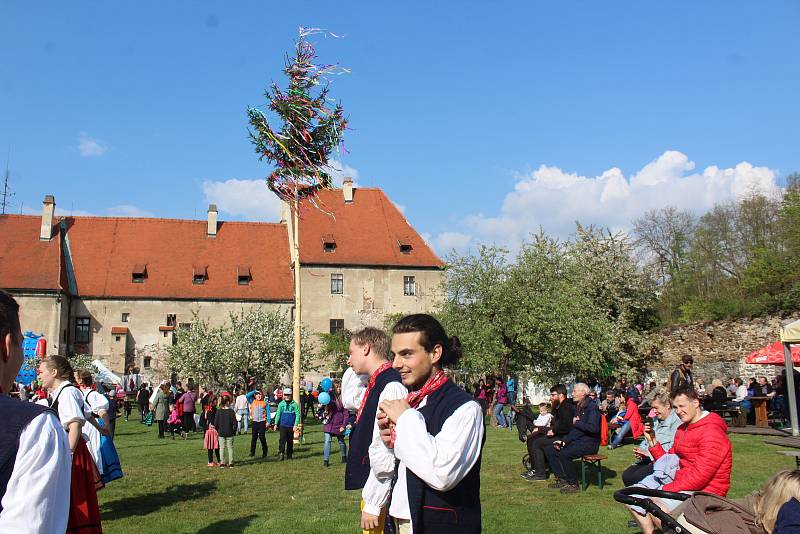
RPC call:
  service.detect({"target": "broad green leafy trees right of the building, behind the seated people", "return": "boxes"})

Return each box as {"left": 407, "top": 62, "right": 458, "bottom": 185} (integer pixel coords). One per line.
{"left": 441, "top": 230, "right": 657, "bottom": 381}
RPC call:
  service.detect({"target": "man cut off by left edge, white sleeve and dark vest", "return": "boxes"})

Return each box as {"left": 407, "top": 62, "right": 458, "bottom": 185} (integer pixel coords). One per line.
{"left": 0, "top": 291, "right": 72, "bottom": 534}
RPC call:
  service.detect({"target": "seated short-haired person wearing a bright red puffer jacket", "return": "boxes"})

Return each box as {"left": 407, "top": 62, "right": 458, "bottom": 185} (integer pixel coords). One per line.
{"left": 633, "top": 386, "right": 733, "bottom": 534}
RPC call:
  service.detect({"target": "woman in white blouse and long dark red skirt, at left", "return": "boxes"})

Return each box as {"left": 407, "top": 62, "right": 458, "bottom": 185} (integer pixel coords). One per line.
{"left": 39, "top": 356, "right": 103, "bottom": 534}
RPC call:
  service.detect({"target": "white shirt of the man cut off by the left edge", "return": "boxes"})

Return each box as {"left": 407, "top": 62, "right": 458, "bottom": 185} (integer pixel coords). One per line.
{"left": 0, "top": 412, "right": 72, "bottom": 534}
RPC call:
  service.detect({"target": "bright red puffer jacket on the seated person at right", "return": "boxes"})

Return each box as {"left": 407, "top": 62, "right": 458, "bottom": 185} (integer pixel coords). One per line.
{"left": 650, "top": 413, "right": 733, "bottom": 497}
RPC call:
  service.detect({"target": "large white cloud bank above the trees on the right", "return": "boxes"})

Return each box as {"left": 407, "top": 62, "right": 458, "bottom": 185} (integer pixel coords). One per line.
{"left": 431, "top": 150, "right": 780, "bottom": 252}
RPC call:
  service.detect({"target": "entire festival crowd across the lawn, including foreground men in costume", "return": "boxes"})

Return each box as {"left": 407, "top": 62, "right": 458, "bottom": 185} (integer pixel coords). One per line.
{"left": 0, "top": 278, "right": 800, "bottom": 534}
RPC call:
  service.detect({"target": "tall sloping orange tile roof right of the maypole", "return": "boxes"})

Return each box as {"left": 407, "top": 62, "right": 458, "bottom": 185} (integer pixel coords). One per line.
{"left": 300, "top": 188, "right": 444, "bottom": 267}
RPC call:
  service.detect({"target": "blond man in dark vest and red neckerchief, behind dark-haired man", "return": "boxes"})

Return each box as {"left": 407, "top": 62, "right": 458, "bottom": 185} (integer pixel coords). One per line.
{"left": 342, "top": 327, "right": 408, "bottom": 533}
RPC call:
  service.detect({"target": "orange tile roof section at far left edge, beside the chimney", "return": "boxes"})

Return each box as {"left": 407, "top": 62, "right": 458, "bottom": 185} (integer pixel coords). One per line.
{"left": 0, "top": 215, "right": 67, "bottom": 290}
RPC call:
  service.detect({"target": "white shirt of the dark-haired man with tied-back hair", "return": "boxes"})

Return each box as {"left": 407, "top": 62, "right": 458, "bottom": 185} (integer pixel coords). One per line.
{"left": 389, "top": 398, "right": 484, "bottom": 527}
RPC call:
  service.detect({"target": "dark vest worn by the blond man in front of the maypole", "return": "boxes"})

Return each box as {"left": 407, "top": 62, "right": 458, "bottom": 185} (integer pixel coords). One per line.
{"left": 344, "top": 367, "right": 401, "bottom": 490}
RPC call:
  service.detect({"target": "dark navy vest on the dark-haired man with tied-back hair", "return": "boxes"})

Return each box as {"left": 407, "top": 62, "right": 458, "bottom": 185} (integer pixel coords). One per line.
{"left": 406, "top": 380, "right": 486, "bottom": 534}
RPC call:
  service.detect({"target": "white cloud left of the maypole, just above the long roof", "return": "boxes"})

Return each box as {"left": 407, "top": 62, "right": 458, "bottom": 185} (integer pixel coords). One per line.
{"left": 203, "top": 178, "right": 281, "bottom": 222}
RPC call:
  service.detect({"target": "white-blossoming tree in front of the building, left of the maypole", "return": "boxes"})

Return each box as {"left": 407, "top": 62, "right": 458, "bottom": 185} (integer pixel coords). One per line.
{"left": 168, "top": 308, "right": 310, "bottom": 387}
